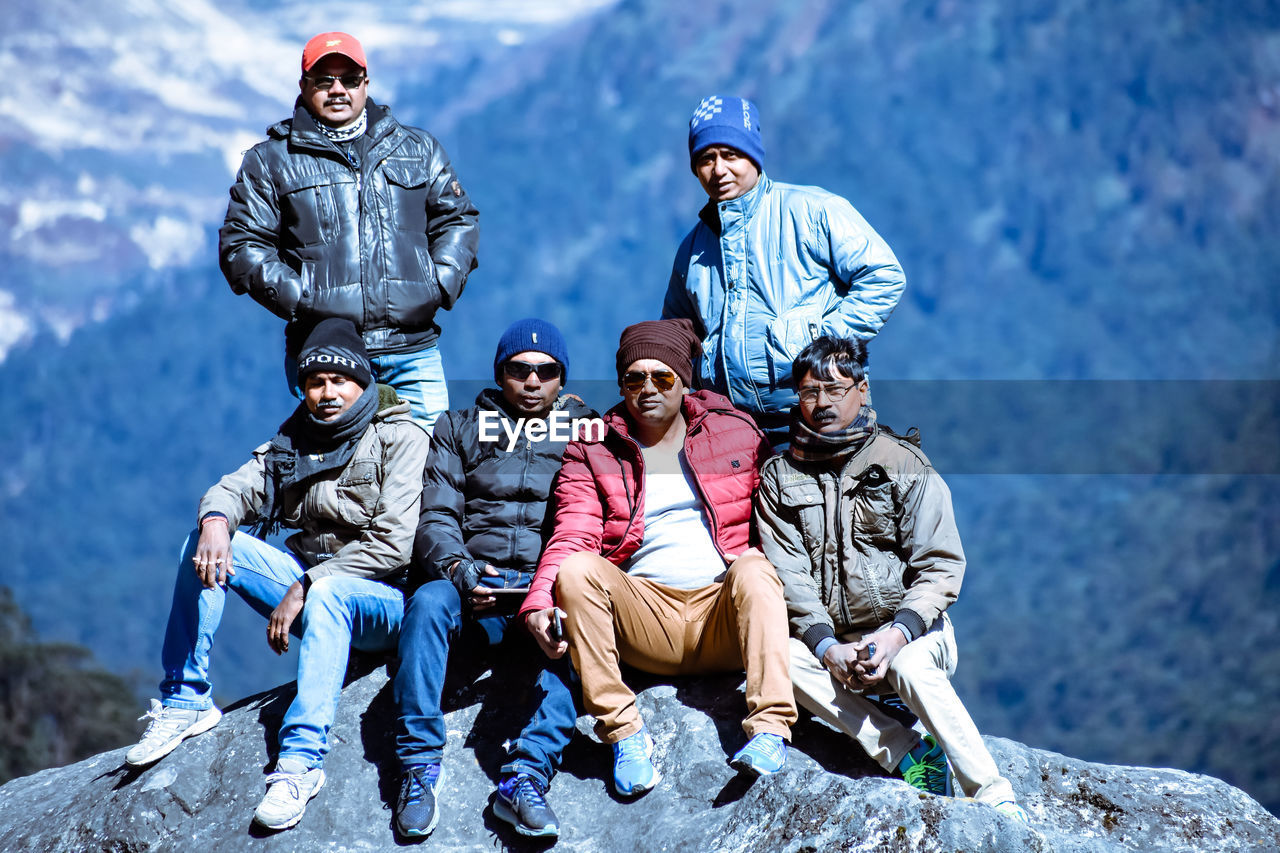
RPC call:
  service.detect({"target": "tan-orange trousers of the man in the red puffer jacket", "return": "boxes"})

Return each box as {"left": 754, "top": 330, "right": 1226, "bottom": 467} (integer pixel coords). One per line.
{"left": 556, "top": 548, "right": 796, "bottom": 743}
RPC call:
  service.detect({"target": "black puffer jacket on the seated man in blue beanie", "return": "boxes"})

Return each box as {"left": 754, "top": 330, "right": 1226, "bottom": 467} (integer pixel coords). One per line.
{"left": 413, "top": 388, "right": 595, "bottom": 581}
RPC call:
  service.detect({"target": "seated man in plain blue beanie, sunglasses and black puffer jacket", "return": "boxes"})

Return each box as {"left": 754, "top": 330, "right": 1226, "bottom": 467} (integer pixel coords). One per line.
{"left": 396, "top": 319, "right": 593, "bottom": 838}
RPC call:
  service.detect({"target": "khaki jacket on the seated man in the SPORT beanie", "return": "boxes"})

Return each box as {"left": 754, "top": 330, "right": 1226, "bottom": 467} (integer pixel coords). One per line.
{"left": 198, "top": 402, "right": 429, "bottom": 581}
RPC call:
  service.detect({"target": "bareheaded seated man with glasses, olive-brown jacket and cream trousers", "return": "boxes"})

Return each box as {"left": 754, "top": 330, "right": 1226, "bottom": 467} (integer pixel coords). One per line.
{"left": 755, "top": 336, "right": 1028, "bottom": 822}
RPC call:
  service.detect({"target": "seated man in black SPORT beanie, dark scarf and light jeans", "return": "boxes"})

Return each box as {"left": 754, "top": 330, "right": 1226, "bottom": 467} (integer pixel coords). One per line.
{"left": 125, "top": 319, "right": 428, "bottom": 829}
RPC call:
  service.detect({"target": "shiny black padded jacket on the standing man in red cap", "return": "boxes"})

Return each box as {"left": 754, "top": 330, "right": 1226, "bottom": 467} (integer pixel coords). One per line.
{"left": 219, "top": 101, "right": 479, "bottom": 355}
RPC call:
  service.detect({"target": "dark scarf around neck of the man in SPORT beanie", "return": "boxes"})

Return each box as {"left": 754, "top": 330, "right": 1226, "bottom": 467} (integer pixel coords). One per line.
{"left": 253, "top": 383, "right": 379, "bottom": 539}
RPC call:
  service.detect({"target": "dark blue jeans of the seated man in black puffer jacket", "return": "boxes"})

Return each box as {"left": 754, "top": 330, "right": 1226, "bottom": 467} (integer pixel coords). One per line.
{"left": 396, "top": 575, "right": 577, "bottom": 788}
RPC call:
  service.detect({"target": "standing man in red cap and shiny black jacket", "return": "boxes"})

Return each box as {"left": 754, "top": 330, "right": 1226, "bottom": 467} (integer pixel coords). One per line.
{"left": 219, "top": 32, "right": 479, "bottom": 428}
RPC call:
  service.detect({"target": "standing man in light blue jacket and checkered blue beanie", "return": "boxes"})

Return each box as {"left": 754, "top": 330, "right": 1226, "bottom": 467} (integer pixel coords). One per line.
{"left": 662, "top": 95, "right": 906, "bottom": 448}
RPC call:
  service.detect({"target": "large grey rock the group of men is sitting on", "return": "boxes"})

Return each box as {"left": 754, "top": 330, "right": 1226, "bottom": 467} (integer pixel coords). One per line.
{"left": 0, "top": 663, "right": 1280, "bottom": 853}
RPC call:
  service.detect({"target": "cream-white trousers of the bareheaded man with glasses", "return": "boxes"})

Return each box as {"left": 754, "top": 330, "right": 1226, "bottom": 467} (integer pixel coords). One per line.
{"left": 790, "top": 613, "right": 1016, "bottom": 806}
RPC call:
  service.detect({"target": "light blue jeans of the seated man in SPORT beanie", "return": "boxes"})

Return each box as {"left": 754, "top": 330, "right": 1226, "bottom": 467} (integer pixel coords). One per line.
{"left": 160, "top": 532, "right": 404, "bottom": 767}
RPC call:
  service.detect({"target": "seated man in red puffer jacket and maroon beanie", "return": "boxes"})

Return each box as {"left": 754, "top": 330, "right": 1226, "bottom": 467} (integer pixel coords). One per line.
{"left": 521, "top": 319, "right": 796, "bottom": 795}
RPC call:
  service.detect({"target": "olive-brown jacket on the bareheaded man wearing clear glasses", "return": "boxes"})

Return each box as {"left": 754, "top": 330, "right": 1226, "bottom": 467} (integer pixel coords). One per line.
{"left": 755, "top": 432, "right": 965, "bottom": 649}
